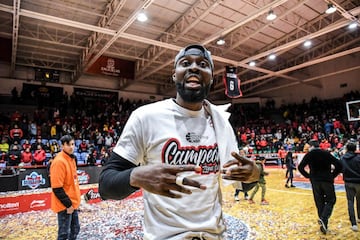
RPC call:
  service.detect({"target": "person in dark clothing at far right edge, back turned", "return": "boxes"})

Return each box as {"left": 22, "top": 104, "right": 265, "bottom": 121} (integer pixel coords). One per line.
{"left": 341, "top": 142, "right": 360, "bottom": 232}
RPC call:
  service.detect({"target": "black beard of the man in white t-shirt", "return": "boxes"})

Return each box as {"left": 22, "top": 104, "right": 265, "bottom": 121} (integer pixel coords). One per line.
{"left": 175, "top": 82, "right": 211, "bottom": 103}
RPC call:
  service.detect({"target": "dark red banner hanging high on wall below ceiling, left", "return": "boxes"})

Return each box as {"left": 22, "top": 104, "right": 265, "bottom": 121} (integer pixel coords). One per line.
{"left": 86, "top": 56, "right": 135, "bottom": 79}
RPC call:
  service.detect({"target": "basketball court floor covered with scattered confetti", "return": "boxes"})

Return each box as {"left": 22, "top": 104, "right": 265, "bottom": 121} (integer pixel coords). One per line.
{"left": 0, "top": 169, "right": 360, "bottom": 240}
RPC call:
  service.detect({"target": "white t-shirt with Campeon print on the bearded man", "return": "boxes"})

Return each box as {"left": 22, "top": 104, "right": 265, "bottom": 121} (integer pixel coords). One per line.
{"left": 114, "top": 99, "right": 236, "bottom": 240}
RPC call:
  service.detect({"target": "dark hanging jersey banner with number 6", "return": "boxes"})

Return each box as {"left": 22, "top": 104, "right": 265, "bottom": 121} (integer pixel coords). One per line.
{"left": 223, "top": 66, "right": 242, "bottom": 98}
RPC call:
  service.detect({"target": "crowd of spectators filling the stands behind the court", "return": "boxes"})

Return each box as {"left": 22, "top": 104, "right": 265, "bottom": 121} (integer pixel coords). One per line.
{"left": 0, "top": 88, "right": 360, "bottom": 174}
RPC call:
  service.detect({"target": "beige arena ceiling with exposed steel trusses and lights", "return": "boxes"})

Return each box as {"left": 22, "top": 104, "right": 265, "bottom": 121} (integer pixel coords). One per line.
{"left": 0, "top": 0, "right": 360, "bottom": 100}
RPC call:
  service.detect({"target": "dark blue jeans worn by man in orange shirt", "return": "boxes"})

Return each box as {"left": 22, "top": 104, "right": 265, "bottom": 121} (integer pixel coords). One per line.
{"left": 57, "top": 210, "right": 80, "bottom": 240}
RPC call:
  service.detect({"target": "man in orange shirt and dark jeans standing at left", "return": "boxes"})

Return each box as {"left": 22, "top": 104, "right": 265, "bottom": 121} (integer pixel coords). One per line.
{"left": 50, "top": 135, "right": 81, "bottom": 240}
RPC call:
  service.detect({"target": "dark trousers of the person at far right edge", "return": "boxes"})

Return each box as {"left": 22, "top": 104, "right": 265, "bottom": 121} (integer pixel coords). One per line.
{"left": 345, "top": 182, "right": 360, "bottom": 225}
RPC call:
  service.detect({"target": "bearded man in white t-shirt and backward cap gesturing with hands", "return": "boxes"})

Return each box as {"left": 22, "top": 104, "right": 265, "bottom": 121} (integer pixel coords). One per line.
{"left": 99, "top": 45, "right": 259, "bottom": 240}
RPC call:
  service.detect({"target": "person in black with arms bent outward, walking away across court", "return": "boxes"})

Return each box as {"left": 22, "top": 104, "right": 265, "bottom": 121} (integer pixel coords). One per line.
{"left": 298, "top": 140, "right": 342, "bottom": 234}
